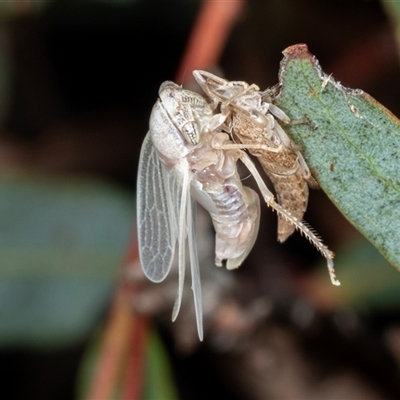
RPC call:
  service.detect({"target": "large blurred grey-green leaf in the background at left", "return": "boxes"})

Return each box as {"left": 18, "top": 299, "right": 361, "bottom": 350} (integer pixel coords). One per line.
{"left": 0, "top": 174, "right": 135, "bottom": 348}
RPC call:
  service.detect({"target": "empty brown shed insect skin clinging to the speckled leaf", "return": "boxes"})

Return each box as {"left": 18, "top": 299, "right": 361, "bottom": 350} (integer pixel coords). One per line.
{"left": 193, "top": 70, "right": 340, "bottom": 285}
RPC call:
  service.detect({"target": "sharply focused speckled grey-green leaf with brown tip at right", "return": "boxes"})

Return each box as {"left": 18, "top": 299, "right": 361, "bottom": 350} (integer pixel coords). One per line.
{"left": 276, "top": 44, "right": 400, "bottom": 269}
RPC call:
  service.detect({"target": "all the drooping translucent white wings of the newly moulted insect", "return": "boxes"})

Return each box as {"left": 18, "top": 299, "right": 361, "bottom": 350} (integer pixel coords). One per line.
{"left": 137, "top": 133, "right": 203, "bottom": 340}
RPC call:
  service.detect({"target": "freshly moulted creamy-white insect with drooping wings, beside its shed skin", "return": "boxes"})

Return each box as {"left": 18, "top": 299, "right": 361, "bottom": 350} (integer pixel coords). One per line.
{"left": 137, "top": 81, "right": 260, "bottom": 340}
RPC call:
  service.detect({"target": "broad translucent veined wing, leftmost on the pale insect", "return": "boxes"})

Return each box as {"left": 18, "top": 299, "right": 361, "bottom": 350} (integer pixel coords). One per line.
{"left": 137, "top": 133, "right": 180, "bottom": 282}
